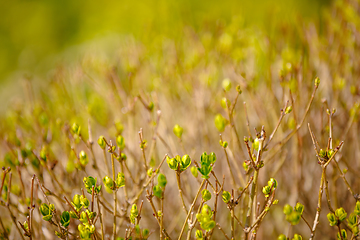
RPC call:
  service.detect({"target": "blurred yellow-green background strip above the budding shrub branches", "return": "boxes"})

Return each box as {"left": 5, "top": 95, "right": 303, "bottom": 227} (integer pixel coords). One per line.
{"left": 0, "top": 0, "right": 330, "bottom": 85}
